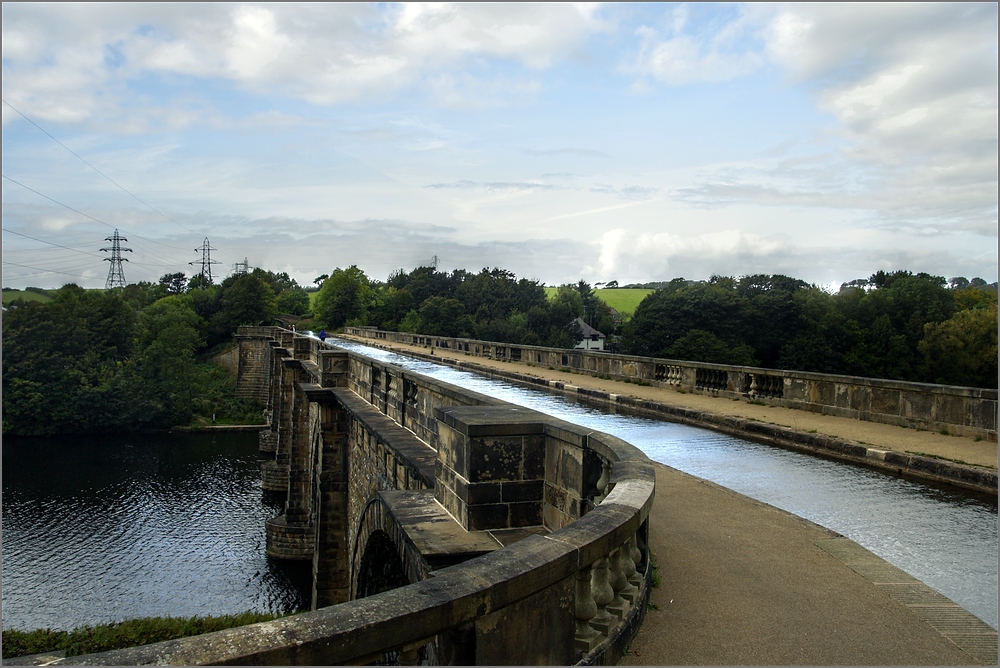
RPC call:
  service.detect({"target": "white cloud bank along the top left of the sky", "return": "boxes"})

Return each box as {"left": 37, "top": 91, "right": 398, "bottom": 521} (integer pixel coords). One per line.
{"left": 3, "top": 3, "right": 609, "bottom": 122}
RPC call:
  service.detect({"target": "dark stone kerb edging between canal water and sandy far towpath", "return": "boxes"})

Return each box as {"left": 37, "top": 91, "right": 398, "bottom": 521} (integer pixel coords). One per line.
{"left": 344, "top": 336, "right": 997, "bottom": 496}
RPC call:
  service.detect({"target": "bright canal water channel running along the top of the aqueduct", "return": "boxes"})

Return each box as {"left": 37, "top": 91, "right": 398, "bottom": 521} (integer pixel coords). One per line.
{"left": 333, "top": 339, "right": 998, "bottom": 628}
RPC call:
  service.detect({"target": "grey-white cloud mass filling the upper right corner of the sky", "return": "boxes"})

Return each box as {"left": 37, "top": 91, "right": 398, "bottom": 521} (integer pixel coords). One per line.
{"left": 637, "top": 4, "right": 998, "bottom": 236}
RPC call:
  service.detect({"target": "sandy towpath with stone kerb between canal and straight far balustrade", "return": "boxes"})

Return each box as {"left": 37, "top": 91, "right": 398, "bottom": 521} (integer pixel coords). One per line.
{"left": 338, "top": 335, "right": 997, "bottom": 495}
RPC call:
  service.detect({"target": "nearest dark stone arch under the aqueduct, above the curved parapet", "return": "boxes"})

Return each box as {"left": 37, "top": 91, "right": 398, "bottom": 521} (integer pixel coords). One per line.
{"left": 351, "top": 494, "right": 429, "bottom": 600}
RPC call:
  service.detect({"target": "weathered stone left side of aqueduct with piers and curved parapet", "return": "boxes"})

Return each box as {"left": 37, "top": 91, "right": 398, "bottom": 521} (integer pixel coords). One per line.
{"left": 73, "top": 327, "right": 655, "bottom": 665}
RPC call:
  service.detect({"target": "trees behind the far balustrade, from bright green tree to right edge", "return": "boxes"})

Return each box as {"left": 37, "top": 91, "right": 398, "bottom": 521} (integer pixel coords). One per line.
{"left": 314, "top": 266, "right": 997, "bottom": 388}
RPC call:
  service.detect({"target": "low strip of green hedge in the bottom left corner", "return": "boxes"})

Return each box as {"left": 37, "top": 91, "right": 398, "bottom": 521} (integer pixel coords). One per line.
{"left": 3, "top": 612, "right": 281, "bottom": 659}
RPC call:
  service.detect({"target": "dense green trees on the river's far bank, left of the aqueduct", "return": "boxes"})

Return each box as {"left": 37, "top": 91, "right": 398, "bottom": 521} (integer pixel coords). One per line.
{"left": 3, "top": 270, "right": 297, "bottom": 435}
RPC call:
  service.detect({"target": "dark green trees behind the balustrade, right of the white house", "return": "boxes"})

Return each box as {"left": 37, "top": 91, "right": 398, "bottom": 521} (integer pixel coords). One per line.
{"left": 623, "top": 271, "right": 997, "bottom": 387}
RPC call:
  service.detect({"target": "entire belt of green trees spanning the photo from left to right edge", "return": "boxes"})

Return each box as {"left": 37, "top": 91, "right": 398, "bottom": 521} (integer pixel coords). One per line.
{"left": 3, "top": 266, "right": 997, "bottom": 435}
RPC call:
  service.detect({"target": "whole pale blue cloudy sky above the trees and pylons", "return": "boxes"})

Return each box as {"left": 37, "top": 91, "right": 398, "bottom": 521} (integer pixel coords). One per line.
{"left": 2, "top": 2, "right": 998, "bottom": 289}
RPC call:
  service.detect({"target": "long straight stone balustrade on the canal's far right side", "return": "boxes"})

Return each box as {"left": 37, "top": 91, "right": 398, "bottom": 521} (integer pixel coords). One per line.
{"left": 344, "top": 327, "right": 997, "bottom": 441}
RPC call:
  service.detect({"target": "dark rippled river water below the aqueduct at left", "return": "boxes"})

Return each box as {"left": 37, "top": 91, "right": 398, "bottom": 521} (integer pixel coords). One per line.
{"left": 3, "top": 433, "right": 309, "bottom": 629}
